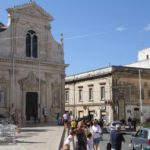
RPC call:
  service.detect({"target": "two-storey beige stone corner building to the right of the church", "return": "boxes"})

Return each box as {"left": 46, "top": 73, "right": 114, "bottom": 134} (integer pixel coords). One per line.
{"left": 65, "top": 49, "right": 150, "bottom": 123}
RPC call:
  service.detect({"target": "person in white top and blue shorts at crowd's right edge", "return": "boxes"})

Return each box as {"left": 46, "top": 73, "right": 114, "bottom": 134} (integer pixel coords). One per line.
{"left": 92, "top": 119, "right": 102, "bottom": 150}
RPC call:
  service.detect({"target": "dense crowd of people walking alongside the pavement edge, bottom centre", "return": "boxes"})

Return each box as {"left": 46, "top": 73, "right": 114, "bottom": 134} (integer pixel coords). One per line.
{"left": 63, "top": 118, "right": 102, "bottom": 150}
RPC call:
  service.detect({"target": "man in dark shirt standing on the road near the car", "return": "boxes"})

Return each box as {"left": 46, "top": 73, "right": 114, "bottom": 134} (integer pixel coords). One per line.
{"left": 110, "top": 124, "right": 125, "bottom": 150}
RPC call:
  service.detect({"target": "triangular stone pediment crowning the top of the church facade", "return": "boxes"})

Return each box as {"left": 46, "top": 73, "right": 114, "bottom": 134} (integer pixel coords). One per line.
{"left": 7, "top": 2, "right": 53, "bottom": 21}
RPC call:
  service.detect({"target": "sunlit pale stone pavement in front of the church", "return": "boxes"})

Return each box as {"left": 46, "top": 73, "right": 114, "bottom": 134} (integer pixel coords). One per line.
{"left": 0, "top": 125, "right": 64, "bottom": 150}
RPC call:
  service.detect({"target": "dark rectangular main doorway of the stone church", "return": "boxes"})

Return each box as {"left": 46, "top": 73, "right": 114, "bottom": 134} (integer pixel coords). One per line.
{"left": 26, "top": 92, "right": 38, "bottom": 120}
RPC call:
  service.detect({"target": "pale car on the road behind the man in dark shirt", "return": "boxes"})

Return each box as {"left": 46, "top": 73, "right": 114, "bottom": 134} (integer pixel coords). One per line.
{"left": 107, "top": 120, "right": 126, "bottom": 133}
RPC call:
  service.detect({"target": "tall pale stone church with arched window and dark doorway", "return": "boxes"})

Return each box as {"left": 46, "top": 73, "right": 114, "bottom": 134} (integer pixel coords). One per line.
{"left": 0, "top": 2, "right": 66, "bottom": 122}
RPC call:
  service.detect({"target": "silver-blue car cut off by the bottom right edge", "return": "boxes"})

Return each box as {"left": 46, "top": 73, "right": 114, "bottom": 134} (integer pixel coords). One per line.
{"left": 131, "top": 128, "right": 150, "bottom": 150}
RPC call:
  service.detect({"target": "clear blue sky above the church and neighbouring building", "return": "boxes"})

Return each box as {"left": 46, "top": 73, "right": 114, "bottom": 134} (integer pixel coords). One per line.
{"left": 0, "top": 0, "right": 150, "bottom": 75}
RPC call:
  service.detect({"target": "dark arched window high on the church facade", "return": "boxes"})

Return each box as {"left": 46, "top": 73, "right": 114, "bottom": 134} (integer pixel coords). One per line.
{"left": 26, "top": 30, "right": 38, "bottom": 58}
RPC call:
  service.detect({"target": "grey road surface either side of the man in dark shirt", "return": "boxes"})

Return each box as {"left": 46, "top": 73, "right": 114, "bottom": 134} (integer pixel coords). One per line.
{"left": 100, "top": 133, "right": 132, "bottom": 150}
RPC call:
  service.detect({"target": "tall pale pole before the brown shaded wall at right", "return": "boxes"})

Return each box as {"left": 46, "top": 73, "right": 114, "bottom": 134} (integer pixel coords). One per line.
{"left": 139, "top": 69, "right": 143, "bottom": 124}
